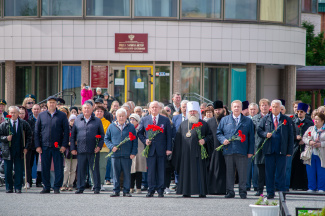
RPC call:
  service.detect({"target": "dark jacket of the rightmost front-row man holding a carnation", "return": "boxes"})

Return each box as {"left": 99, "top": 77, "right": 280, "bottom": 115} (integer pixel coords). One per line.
{"left": 257, "top": 113, "right": 294, "bottom": 155}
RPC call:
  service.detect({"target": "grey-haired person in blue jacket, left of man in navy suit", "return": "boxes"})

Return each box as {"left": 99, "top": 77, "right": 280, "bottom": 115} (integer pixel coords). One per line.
{"left": 104, "top": 108, "right": 138, "bottom": 197}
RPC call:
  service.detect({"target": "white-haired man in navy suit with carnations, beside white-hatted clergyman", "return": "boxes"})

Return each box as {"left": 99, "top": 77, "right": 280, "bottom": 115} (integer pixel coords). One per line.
{"left": 138, "top": 101, "right": 172, "bottom": 197}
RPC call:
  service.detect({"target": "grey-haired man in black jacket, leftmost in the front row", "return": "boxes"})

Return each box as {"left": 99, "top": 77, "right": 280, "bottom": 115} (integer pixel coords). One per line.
{"left": 0, "top": 106, "right": 33, "bottom": 193}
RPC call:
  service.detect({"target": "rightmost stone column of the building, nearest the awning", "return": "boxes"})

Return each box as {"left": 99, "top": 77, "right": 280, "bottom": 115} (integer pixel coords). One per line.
{"left": 282, "top": 65, "right": 296, "bottom": 114}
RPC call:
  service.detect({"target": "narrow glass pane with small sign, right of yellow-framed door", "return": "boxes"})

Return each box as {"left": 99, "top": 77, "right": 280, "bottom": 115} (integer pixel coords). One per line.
{"left": 155, "top": 66, "right": 170, "bottom": 104}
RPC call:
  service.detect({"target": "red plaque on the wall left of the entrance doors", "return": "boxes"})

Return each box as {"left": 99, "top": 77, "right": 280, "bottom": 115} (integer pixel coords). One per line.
{"left": 91, "top": 66, "right": 108, "bottom": 88}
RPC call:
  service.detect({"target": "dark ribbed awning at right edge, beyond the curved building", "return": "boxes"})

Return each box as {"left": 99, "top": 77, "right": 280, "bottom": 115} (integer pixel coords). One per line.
{"left": 297, "top": 66, "right": 325, "bottom": 90}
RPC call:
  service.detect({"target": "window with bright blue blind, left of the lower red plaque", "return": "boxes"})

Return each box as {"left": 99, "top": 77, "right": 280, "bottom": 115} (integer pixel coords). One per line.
{"left": 62, "top": 66, "right": 81, "bottom": 105}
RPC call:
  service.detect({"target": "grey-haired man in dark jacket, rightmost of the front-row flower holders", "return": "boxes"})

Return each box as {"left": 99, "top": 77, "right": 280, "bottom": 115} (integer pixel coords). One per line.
{"left": 257, "top": 100, "right": 294, "bottom": 199}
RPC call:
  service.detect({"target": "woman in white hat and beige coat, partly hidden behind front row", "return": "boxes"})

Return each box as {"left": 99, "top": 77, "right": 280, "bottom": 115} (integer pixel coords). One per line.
{"left": 130, "top": 113, "right": 147, "bottom": 194}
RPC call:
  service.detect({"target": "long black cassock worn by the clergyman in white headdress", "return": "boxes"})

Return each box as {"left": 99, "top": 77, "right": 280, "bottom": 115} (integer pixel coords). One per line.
{"left": 172, "top": 120, "right": 213, "bottom": 195}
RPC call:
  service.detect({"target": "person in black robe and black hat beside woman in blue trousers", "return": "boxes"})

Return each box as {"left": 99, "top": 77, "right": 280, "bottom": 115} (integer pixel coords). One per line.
{"left": 290, "top": 103, "right": 314, "bottom": 190}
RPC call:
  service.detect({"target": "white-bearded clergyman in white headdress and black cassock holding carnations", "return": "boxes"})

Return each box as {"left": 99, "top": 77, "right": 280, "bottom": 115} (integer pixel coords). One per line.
{"left": 172, "top": 101, "right": 213, "bottom": 198}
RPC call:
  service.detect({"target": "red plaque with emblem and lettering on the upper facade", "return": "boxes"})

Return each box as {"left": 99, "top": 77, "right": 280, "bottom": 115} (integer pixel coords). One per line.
{"left": 115, "top": 33, "right": 148, "bottom": 53}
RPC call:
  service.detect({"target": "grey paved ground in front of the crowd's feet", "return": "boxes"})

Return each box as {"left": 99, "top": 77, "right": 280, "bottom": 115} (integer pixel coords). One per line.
{"left": 0, "top": 185, "right": 325, "bottom": 216}
